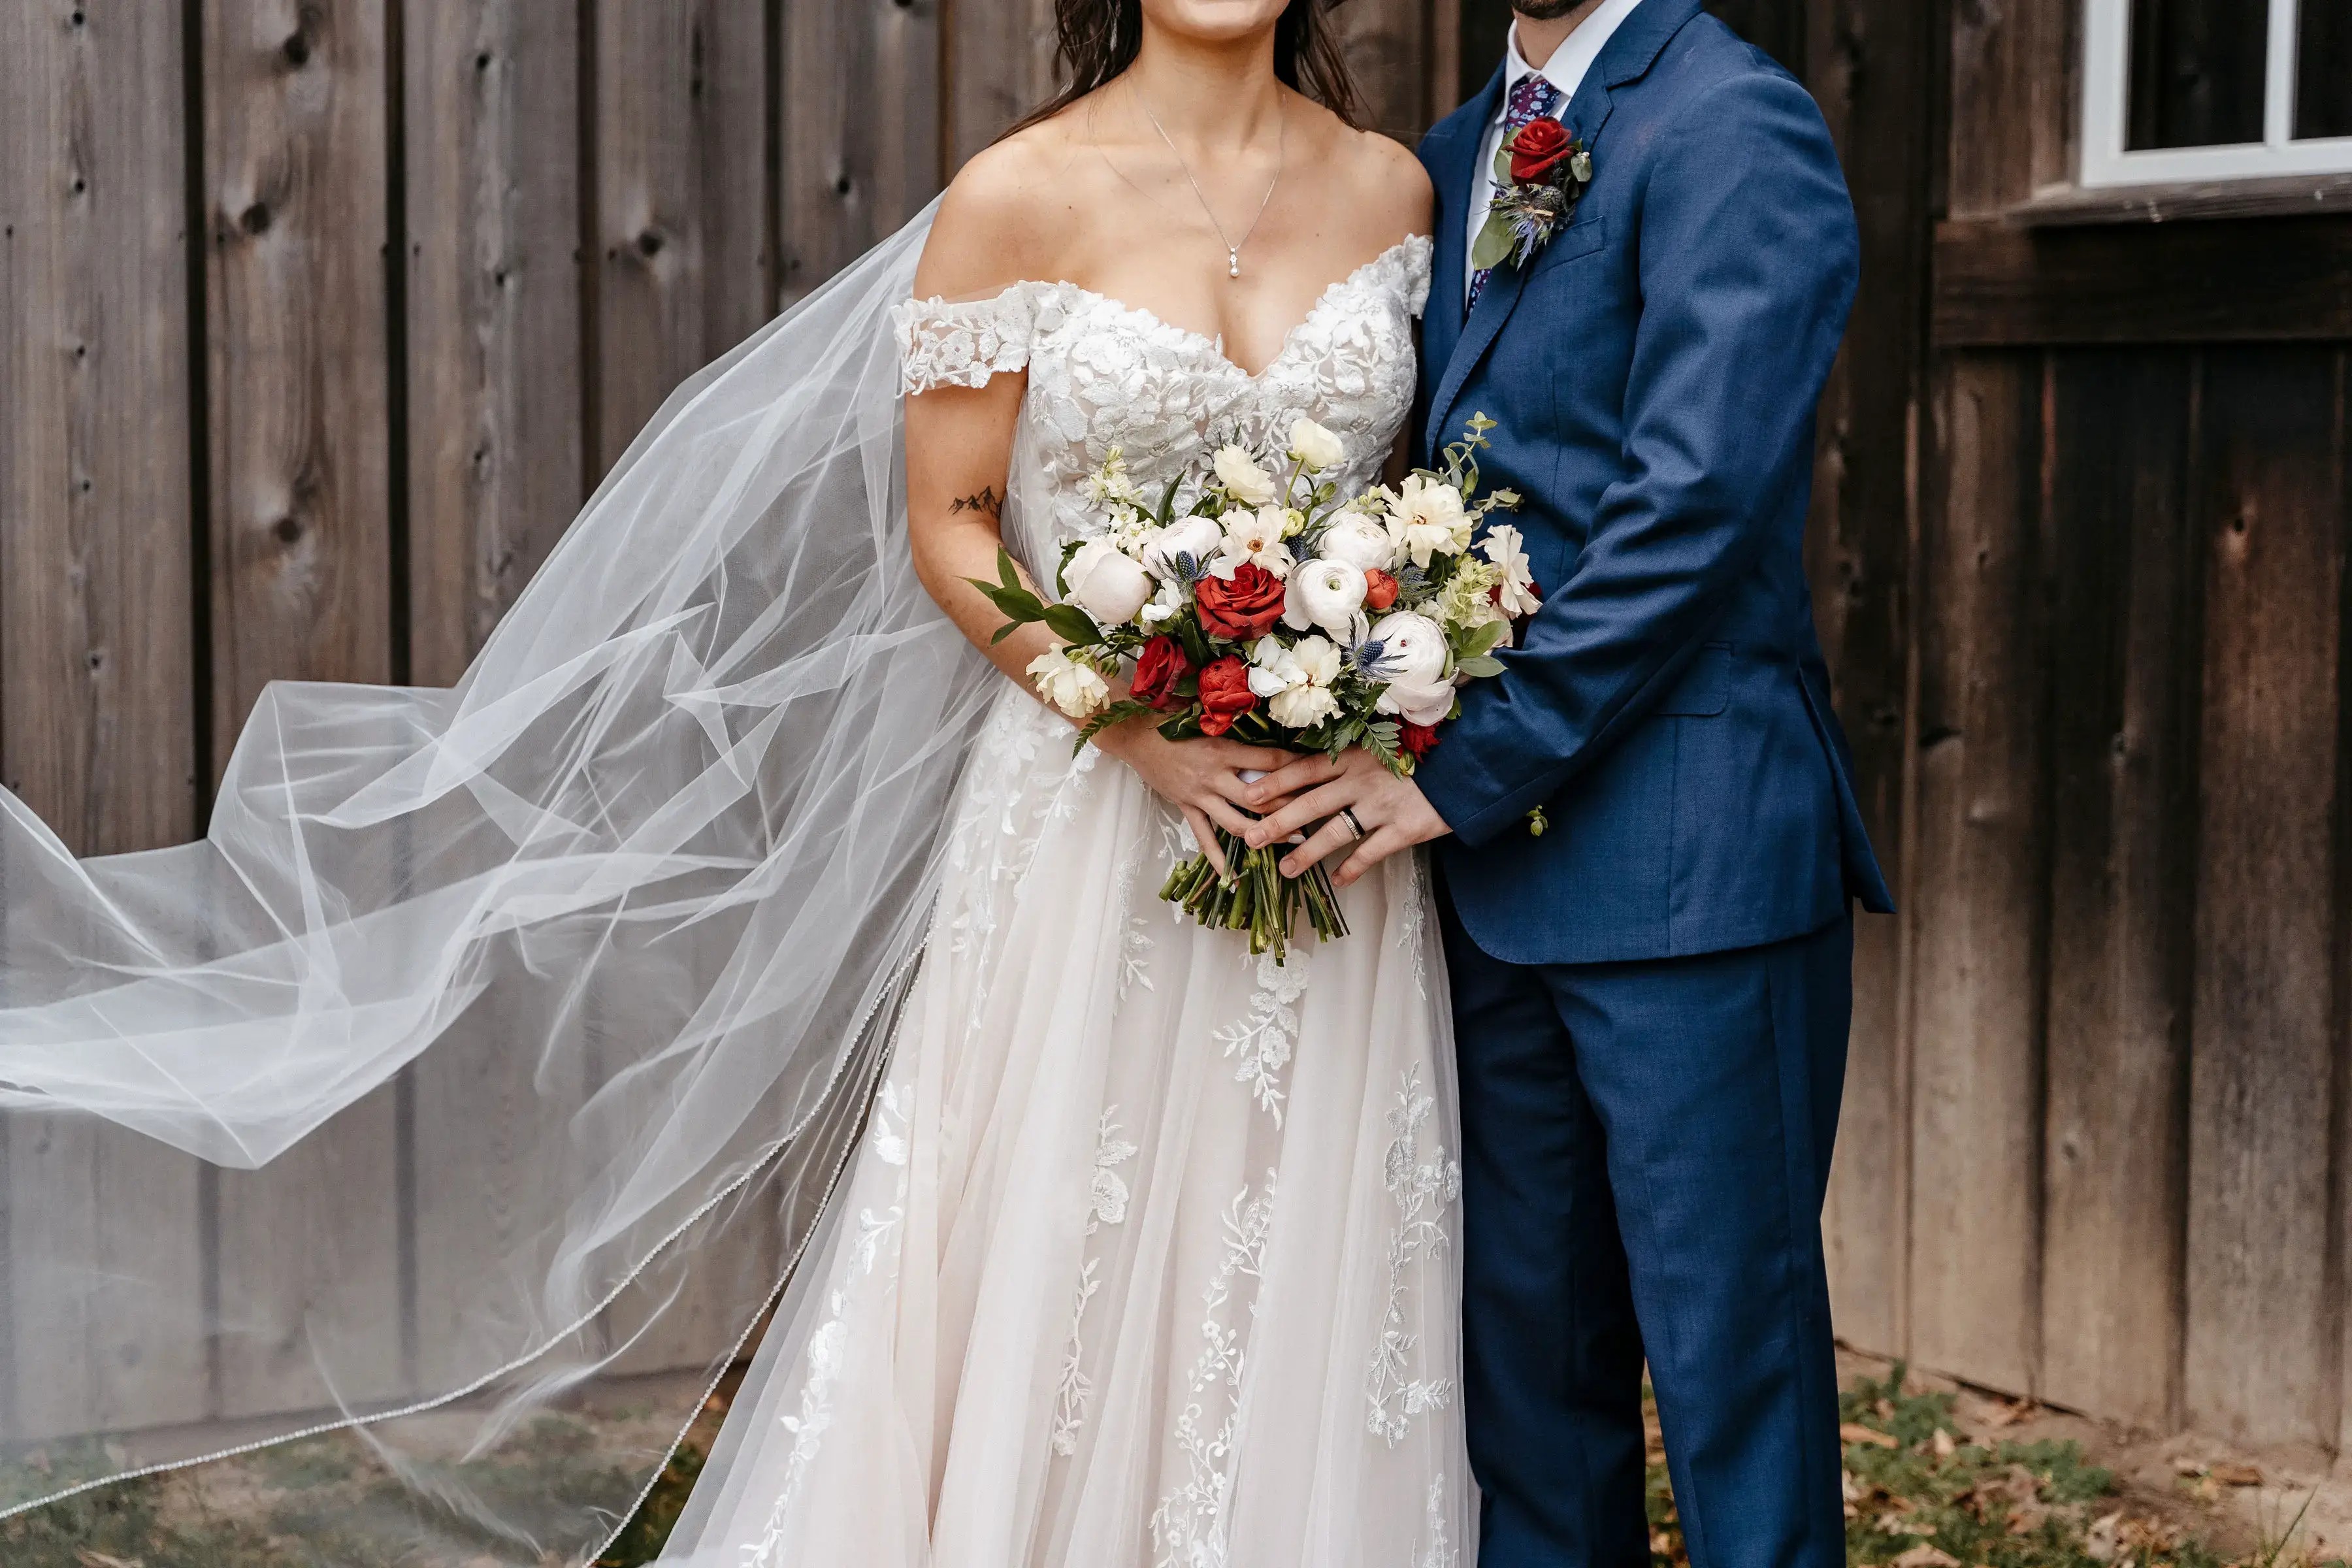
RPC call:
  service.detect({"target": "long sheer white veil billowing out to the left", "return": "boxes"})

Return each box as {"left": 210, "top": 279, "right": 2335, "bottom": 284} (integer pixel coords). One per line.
{"left": 0, "top": 212, "right": 997, "bottom": 1563}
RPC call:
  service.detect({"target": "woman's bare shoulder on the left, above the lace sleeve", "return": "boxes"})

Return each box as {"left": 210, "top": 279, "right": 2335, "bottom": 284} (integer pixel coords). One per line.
{"left": 915, "top": 110, "right": 1086, "bottom": 299}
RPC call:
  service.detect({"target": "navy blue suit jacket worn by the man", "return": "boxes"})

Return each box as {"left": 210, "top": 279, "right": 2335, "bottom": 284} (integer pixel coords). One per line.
{"left": 1418, "top": 0, "right": 1891, "bottom": 964}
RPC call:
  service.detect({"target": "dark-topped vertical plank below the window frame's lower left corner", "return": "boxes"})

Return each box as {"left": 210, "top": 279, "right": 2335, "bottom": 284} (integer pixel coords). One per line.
{"left": 2042, "top": 353, "right": 2202, "bottom": 1429}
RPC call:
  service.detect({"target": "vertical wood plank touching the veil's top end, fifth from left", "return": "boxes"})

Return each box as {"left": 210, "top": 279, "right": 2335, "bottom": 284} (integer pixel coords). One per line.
{"left": 776, "top": 0, "right": 941, "bottom": 303}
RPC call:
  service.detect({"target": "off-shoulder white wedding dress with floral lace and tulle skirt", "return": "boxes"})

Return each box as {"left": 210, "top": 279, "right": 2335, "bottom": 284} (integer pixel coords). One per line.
{"left": 668, "top": 240, "right": 1470, "bottom": 1568}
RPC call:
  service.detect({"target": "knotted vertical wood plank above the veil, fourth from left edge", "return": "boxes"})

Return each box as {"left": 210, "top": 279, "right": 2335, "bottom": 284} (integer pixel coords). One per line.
{"left": 591, "top": 0, "right": 774, "bottom": 472}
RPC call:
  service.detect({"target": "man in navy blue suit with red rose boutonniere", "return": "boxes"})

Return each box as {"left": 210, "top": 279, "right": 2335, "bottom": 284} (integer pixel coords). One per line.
{"left": 1258, "top": 0, "right": 1889, "bottom": 1568}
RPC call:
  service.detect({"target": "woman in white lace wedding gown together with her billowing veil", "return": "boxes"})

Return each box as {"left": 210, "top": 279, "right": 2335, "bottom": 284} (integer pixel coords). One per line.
{"left": 0, "top": 0, "right": 1473, "bottom": 1568}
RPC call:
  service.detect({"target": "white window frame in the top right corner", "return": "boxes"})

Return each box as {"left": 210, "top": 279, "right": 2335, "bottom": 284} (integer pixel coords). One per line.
{"left": 2082, "top": 0, "right": 2352, "bottom": 190}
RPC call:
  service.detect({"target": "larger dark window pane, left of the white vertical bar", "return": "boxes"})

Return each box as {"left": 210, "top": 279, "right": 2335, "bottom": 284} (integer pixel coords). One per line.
{"left": 2126, "top": 0, "right": 2267, "bottom": 150}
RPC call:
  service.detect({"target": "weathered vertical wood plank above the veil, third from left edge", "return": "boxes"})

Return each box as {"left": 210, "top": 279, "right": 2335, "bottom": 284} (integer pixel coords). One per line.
{"left": 402, "top": 0, "right": 585, "bottom": 687}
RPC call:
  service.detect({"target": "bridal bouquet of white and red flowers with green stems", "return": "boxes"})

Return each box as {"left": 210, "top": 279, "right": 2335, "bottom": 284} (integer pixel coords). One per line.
{"left": 972, "top": 416, "right": 1538, "bottom": 959}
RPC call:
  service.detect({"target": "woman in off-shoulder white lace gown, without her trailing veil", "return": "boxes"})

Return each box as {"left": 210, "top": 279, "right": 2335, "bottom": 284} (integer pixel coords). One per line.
{"left": 673, "top": 0, "right": 1467, "bottom": 1568}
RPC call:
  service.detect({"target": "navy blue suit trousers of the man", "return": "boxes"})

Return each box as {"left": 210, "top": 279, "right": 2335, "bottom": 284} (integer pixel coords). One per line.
{"left": 1442, "top": 898, "right": 1854, "bottom": 1568}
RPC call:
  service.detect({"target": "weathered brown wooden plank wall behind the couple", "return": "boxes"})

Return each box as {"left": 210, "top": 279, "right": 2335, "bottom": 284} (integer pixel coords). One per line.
{"left": 0, "top": 0, "right": 2352, "bottom": 1446}
